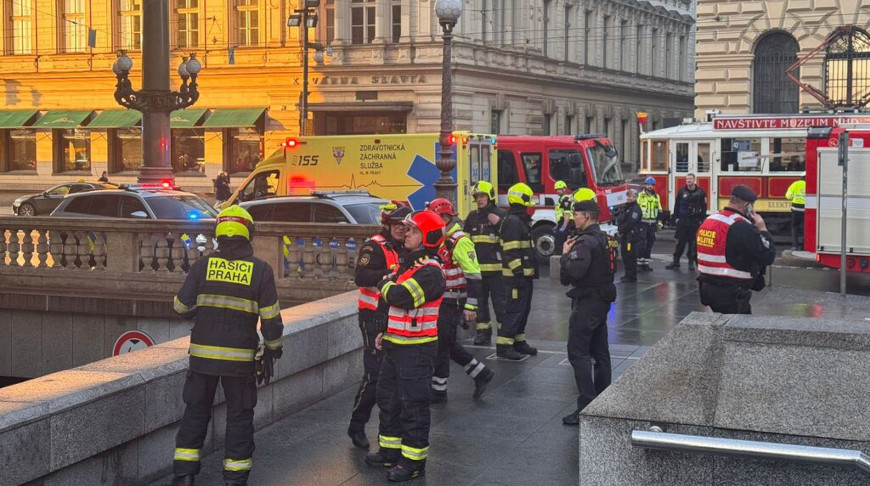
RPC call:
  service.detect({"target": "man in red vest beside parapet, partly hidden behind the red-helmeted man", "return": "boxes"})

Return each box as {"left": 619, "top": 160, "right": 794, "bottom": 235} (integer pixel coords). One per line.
{"left": 347, "top": 201, "right": 411, "bottom": 449}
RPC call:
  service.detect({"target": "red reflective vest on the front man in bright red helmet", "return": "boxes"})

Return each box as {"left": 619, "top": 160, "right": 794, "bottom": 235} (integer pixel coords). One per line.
{"left": 384, "top": 258, "right": 443, "bottom": 345}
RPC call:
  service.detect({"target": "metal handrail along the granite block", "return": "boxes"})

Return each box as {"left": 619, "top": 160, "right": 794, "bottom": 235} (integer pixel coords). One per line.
{"left": 631, "top": 426, "right": 870, "bottom": 475}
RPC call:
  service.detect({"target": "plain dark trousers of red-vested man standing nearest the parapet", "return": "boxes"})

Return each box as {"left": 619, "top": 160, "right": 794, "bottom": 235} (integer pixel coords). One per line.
{"left": 350, "top": 313, "right": 385, "bottom": 430}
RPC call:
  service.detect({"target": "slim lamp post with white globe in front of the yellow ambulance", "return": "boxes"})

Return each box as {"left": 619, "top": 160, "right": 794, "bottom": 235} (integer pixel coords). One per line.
{"left": 435, "top": 0, "right": 462, "bottom": 203}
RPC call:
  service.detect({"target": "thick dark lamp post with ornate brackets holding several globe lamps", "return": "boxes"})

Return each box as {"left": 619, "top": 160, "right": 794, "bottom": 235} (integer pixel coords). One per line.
{"left": 112, "top": 0, "right": 202, "bottom": 185}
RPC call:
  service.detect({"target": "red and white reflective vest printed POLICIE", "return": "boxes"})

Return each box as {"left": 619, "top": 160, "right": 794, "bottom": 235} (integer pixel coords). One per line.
{"left": 697, "top": 211, "right": 753, "bottom": 281}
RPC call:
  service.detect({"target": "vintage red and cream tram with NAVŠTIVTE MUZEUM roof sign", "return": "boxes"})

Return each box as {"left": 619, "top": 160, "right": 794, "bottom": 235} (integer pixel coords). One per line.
{"left": 640, "top": 114, "right": 870, "bottom": 234}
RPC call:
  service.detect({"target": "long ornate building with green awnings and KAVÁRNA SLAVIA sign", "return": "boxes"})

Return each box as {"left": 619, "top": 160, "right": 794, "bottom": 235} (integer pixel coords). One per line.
{"left": 0, "top": 0, "right": 695, "bottom": 191}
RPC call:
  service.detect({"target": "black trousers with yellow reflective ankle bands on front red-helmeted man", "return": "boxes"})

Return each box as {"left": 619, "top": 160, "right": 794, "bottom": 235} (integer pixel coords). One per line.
{"left": 378, "top": 341, "right": 438, "bottom": 468}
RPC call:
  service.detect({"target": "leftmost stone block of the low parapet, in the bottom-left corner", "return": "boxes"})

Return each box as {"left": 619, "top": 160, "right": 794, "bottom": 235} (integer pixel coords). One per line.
{"left": 0, "top": 402, "right": 51, "bottom": 484}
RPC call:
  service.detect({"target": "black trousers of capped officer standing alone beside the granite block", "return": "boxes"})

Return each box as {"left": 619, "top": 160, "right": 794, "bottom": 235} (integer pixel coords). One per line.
{"left": 568, "top": 295, "right": 611, "bottom": 410}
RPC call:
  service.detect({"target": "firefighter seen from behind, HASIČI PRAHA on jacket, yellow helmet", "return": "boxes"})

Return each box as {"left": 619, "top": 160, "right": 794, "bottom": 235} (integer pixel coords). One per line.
{"left": 172, "top": 206, "right": 284, "bottom": 485}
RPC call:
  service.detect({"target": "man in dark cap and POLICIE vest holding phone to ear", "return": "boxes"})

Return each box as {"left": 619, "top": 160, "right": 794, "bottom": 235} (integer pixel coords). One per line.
{"left": 697, "top": 185, "right": 776, "bottom": 314}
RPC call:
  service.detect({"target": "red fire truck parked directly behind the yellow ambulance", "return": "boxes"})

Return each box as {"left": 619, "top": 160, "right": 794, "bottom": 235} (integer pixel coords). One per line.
{"left": 497, "top": 134, "right": 628, "bottom": 257}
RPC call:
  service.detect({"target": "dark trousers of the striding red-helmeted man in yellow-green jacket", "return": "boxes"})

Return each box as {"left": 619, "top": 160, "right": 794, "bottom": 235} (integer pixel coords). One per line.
{"left": 432, "top": 301, "right": 486, "bottom": 392}
